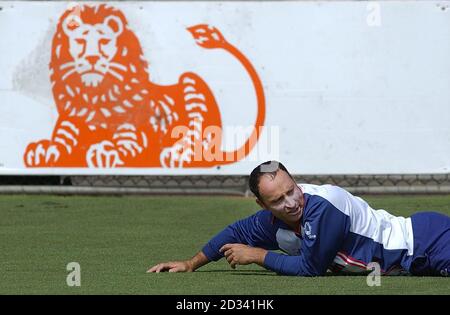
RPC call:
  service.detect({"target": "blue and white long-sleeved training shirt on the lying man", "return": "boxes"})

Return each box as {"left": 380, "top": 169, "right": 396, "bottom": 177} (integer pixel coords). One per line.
{"left": 202, "top": 184, "right": 413, "bottom": 276}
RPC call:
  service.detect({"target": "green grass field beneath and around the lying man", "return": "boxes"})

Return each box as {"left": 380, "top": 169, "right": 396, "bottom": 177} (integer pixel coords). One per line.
{"left": 0, "top": 195, "right": 450, "bottom": 295}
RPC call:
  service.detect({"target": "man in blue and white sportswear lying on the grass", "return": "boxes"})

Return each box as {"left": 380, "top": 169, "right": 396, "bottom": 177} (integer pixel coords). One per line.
{"left": 148, "top": 161, "right": 450, "bottom": 276}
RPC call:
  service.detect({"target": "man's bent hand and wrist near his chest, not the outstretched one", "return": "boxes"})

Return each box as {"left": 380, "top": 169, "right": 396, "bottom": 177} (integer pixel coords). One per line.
{"left": 220, "top": 244, "right": 267, "bottom": 269}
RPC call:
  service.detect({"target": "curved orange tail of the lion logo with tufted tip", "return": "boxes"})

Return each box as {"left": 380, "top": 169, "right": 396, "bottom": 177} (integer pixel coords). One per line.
{"left": 188, "top": 24, "right": 266, "bottom": 165}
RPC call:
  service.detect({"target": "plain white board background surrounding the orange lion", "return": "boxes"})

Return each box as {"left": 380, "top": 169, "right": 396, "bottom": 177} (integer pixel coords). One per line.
{"left": 0, "top": 1, "right": 450, "bottom": 174}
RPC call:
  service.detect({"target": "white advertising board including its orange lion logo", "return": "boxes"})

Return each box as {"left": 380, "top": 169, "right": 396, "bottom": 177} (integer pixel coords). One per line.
{"left": 0, "top": 1, "right": 450, "bottom": 175}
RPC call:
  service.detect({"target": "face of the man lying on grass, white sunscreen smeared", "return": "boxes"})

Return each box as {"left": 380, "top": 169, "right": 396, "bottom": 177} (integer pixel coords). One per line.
{"left": 259, "top": 170, "right": 304, "bottom": 224}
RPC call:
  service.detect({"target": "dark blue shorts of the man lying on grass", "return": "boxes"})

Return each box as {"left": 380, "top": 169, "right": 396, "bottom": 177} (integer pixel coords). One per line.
{"left": 409, "top": 212, "right": 450, "bottom": 276}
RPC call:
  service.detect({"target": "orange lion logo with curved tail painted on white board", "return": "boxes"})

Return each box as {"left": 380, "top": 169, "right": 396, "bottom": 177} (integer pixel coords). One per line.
{"left": 24, "top": 4, "right": 265, "bottom": 168}
